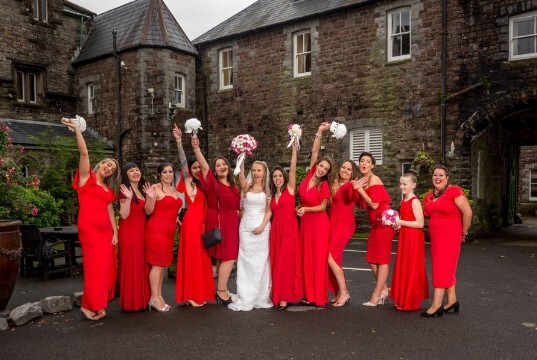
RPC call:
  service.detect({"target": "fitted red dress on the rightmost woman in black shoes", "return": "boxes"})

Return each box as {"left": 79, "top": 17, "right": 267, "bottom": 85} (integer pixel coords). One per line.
{"left": 424, "top": 185, "right": 464, "bottom": 289}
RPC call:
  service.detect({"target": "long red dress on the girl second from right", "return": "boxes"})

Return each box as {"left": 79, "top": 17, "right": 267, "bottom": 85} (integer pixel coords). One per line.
{"left": 390, "top": 196, "right": 429, "bottom": 310}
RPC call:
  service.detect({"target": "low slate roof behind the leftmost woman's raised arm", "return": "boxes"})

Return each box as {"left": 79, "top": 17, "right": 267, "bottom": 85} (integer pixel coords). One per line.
{"left": 0, "top": 118, "right": 114, "bottom": 153}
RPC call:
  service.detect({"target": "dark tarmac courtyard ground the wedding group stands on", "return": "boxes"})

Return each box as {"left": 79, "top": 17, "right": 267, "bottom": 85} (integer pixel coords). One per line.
{"left": 0, "top": 224, "right": 537, "bottom": 359}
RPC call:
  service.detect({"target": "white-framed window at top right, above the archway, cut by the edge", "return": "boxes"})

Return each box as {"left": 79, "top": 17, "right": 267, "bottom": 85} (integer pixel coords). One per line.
{"left": 509, "top": 11, "right": 537, "bottom": 60}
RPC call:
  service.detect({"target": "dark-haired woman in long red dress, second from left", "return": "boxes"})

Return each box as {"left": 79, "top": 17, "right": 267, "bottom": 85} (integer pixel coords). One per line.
{"left": 119, "top": 163, "right": 151, "bottom": 311}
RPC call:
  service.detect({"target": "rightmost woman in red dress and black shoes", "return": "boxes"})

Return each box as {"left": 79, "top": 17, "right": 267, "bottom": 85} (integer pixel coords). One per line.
{"left": 421, "top": 165, "right": 473, "bottom": 317}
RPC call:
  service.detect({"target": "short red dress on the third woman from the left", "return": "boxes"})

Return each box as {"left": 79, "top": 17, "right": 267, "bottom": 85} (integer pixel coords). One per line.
{"left": 144, "top": 195, "right": 183, "bottom": 267}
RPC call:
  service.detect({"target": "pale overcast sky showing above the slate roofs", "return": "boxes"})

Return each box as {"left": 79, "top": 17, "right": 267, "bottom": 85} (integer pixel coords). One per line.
{"left": 70, "top": 0, "right": 256, "bottom": 40}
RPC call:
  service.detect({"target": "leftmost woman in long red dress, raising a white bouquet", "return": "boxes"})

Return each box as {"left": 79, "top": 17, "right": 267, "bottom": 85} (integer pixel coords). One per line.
{"left": 62, "top": 118, "right": 118, "bottom": 320}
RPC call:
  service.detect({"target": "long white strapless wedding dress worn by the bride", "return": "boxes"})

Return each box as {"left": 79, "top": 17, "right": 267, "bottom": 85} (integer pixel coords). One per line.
{"left": 228, "top": 191, "right": 272, "bottom": 311}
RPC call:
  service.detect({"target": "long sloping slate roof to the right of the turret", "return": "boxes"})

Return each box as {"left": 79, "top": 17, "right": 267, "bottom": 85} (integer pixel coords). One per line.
{"left": 192, "top": 0, "right": 372, "bottom": 44}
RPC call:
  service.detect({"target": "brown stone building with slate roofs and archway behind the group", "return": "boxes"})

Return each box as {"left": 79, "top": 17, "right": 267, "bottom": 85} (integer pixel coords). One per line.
{"left": 0, "top": 0, "right": 537, "bottom": 231}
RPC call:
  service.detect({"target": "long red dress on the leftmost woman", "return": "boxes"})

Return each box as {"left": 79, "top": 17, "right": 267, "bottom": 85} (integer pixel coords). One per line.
{"left": 73, "top": 170, "right": 116, "bottom": 311}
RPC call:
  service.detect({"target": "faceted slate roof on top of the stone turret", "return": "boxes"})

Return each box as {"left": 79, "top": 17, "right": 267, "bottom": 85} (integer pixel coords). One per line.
{"left": 75, "top": 0, "right": 198, "bottom": 63}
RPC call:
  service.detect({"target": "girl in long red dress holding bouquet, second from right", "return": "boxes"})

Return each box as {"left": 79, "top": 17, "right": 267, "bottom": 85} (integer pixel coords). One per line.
{"left": 390, "top": 173, "right": 429, "bottom": 310}
